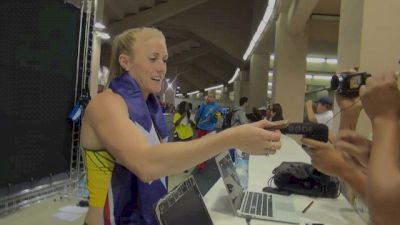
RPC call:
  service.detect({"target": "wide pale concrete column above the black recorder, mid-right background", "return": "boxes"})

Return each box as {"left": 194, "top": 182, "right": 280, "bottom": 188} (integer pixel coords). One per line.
{"left": 272, "top": 13, "right": 308, "bottom": 122}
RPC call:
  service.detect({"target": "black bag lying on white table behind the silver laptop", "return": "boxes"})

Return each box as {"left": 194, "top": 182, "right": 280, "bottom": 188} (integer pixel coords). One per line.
{"left": 271, "top": 162, "right": 340, "bottom": 198}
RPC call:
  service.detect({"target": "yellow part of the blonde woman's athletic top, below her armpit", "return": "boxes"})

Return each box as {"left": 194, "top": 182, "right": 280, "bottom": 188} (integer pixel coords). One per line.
{"left": 85, "top": 150, "right": 115, "bottom": 208}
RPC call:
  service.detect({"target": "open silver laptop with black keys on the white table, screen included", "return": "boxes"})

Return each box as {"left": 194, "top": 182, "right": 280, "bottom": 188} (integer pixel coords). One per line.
{"left": 215, "top": 152, "right": 299, "bottom": 224}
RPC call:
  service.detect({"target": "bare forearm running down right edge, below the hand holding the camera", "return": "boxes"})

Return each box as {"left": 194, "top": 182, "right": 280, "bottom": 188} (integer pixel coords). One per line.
{"left": 367, "top": 118, "right": 400, "bottom": 224}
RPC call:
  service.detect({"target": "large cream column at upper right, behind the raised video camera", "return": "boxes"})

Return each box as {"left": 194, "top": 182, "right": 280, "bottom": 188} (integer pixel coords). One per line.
{"left": 334, "top": 0, "right": 400, "bottom": 136}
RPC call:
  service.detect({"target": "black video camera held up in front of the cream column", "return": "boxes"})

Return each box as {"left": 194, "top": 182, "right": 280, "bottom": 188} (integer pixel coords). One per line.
{"left": 331, "top": 72, "right": 371, "bottom": 97}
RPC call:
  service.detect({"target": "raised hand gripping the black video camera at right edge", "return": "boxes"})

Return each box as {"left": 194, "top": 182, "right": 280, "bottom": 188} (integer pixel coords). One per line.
{"left": 360, "top": 73, "right": 400, "bottom": 122}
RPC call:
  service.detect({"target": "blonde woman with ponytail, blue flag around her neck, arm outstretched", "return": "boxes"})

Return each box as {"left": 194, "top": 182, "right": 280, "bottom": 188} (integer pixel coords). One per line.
{"left": 81, "top": 28, "right": 280, "bottom": 225}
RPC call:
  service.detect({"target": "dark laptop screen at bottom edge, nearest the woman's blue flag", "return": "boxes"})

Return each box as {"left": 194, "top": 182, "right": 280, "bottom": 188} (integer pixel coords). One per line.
{"left": 156, "top": 176, "right": 213, "bottom": 225}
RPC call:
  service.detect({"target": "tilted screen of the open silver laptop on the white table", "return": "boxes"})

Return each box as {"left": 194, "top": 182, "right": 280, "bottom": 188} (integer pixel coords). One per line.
{"left": 215, "top": 153, "right": 244, "bottom": 211}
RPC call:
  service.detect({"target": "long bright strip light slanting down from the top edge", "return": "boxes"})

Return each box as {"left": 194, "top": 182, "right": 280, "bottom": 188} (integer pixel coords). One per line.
{"left": 242, "top": 0, "right": 276, "bottom": 61}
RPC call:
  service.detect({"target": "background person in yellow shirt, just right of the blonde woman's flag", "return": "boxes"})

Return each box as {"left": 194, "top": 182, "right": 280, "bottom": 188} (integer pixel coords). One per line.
{"left": 173, "top": 101, "right": 194, "bottom": 141}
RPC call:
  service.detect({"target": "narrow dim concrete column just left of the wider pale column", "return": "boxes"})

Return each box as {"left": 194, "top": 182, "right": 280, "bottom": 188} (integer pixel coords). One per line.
{"left": 248, "top": 54, "right": 269, "bottom": 108}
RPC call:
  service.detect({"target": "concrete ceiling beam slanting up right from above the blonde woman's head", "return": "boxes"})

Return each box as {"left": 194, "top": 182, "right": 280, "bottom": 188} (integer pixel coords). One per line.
{"left": 109, "top": 0, "right": 208, "bottom": 35}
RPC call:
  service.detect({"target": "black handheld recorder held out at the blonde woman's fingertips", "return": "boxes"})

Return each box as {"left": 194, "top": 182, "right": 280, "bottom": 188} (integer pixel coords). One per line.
{"left": 281, "top": 123, "right": 329, "bottom": 142}
